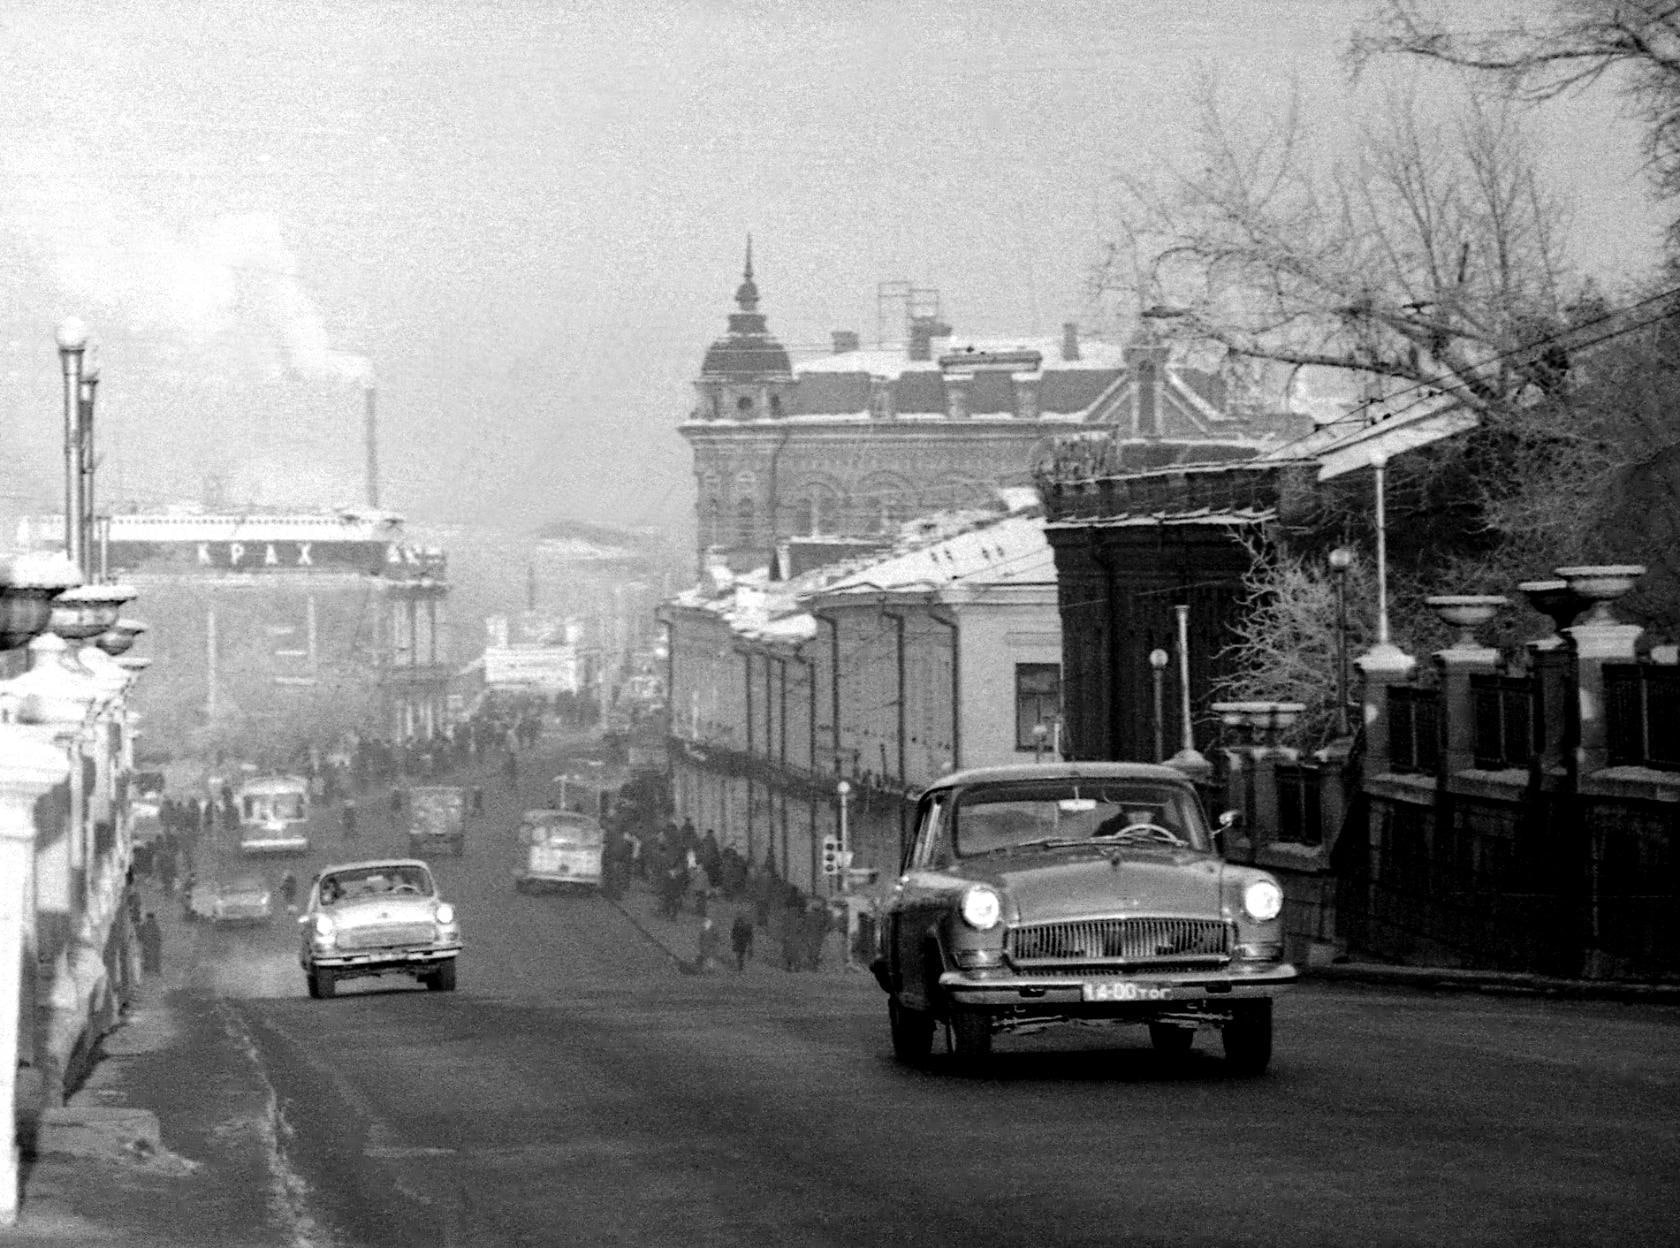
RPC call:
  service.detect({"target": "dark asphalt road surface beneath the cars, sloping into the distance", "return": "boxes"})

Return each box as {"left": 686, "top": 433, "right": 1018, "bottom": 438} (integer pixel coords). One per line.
{"left": 167, "top": 752, "right": 1680, "bottom": 1248}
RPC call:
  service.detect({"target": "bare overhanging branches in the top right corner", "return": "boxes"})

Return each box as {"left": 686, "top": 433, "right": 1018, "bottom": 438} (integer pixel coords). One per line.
{"left": 1352, "top": 0, "right": 1680, "bottom": 250}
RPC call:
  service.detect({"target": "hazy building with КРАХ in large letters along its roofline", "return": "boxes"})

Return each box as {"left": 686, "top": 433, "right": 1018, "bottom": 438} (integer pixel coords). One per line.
{"left": 20, "top": 512, "right": 450, "bottom": 758}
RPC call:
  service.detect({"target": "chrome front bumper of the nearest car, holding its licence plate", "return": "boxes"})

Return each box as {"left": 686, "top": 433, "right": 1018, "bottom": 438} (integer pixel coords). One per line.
{"left": 939, "top": 962, "right": 1299, "bottom": 1016}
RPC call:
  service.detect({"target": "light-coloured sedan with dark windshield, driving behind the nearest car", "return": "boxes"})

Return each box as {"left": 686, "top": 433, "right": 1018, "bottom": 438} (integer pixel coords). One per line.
{"left": 297, "top": 858, "right": 462, "bottom": 998}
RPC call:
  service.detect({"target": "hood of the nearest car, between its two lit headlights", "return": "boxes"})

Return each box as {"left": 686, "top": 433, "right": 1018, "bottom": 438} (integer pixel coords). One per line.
{"left": 968, "top": 848, "right": 1223, "bottom": 922}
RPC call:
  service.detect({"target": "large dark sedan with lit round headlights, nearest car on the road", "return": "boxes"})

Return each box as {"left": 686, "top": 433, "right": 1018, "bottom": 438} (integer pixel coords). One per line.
{"left": 870, "top": 763, "right": 1295, "bottom": 1075}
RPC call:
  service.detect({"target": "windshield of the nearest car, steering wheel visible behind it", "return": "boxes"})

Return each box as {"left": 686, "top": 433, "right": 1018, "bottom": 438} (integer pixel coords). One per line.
{"left": 951, "top": 778, "right": 1208, "bottom": 858}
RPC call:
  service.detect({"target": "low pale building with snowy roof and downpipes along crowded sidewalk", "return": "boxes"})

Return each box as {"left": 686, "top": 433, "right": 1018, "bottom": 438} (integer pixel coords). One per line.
{"left": 660, "top": 512, "right": 1062, "bottom": 895}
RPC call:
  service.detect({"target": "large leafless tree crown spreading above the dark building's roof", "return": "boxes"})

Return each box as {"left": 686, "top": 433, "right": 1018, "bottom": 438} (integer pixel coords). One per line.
{"left": 1097, "top": 87, "right": 1583, "bottom": 429}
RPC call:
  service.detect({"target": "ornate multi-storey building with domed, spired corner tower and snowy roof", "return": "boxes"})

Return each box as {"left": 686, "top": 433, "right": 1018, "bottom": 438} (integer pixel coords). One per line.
{"left": 680, "top": 250, "right": 1300, "bottom": 571}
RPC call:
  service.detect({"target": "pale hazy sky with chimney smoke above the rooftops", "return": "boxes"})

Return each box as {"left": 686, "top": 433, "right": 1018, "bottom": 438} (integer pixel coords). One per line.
{"left": 0, "top": 0, "right": 1656, "bottom": 532}
